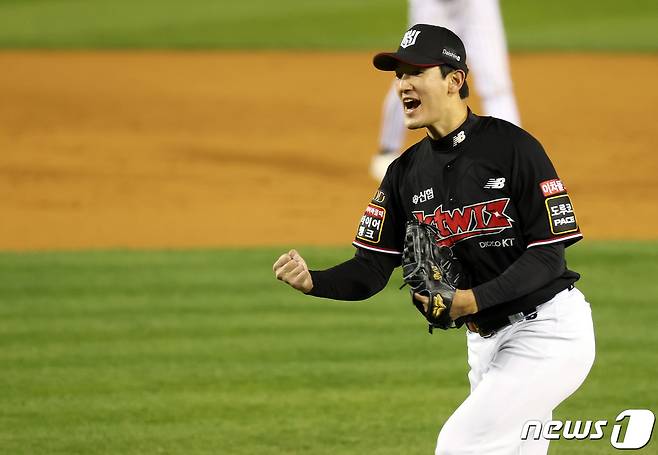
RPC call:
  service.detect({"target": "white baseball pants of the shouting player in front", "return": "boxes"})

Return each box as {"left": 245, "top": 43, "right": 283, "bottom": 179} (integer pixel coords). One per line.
{"left": 436, "top": 288, "right": 594, "bottom": 455}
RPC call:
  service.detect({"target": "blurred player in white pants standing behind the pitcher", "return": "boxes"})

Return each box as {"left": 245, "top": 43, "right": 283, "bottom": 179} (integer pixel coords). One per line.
{"left": 370, "top": 0, "right": 520, "bottom": 181}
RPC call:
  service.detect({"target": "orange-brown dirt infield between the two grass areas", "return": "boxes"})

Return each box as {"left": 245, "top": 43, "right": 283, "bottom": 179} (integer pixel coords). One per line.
{"left": 0, "top": 52, "right": 658, "bottom": 250}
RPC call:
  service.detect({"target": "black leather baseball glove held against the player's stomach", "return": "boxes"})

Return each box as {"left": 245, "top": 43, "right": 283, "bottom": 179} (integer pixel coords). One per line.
{"left": 402, "top": 220, "right": 465, "bottom": 333}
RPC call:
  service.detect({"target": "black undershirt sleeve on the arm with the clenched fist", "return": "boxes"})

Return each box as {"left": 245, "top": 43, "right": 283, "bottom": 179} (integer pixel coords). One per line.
{"left": 308, "top": 248, "right": 400, "bottom": 300}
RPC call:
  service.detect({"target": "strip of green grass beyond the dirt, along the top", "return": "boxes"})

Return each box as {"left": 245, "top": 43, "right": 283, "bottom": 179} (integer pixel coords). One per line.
{"left": 0, "top": 0, "right": 658, "bottom": 51}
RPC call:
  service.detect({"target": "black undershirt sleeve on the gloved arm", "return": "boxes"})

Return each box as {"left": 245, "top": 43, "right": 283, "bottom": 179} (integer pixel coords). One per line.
{"left": 473, "top": 243, "right": 566, "bottom": 311}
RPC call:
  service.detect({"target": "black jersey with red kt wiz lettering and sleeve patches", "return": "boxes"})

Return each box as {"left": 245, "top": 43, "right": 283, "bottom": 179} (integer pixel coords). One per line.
{"left": 354, "top": 111, "right": 582, "bottom": 316}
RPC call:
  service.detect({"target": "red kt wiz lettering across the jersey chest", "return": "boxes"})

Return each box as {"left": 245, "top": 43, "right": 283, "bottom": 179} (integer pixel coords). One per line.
{"left": 413, "top": 198, "right": 514, "bottom": 246}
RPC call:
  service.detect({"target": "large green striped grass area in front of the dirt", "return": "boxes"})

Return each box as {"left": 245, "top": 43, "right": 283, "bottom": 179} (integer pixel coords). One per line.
{"left": 0, "top": 242, "right": 658, "bottom": 455}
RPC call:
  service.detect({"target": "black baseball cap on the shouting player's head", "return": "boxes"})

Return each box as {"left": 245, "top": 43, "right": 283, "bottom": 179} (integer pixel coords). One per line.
{"left": 372, "top": 24, "right": 468, "bottom": 74}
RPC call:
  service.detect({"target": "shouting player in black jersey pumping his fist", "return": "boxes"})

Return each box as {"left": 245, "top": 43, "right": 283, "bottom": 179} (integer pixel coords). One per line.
{"left": 273, "top": 24, "right": 594, "bottom": 455}
